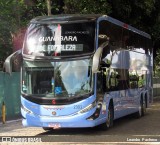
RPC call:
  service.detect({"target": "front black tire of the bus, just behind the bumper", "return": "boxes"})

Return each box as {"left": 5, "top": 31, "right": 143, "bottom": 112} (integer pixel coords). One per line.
{"left": 100, "top": 103, "right": 114, "bottom": 130}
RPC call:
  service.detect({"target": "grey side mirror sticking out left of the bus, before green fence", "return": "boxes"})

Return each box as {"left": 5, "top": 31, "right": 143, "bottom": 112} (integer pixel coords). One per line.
{"left": 4, "top": 50, "right": 22, "bottom": 75}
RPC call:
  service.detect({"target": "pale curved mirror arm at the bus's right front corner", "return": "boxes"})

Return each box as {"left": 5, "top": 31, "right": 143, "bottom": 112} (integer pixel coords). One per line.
{"left": 92, "top": 41, "right": 109, "bottom": 73}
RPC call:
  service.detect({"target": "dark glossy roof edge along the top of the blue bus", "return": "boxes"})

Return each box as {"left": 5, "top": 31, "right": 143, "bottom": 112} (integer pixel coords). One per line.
{"left": 30, "top": 14, "right": 151, "bottom": 39}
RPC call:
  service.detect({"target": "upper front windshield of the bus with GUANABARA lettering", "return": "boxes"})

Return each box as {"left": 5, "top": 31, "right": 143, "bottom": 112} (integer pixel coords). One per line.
{"left": 23, "top": 22, "right": 95, "bottom": 56}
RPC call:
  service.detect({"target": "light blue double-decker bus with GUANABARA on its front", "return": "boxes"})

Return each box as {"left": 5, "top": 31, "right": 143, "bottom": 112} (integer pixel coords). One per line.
{"left": 5, "top": 15, "right": 153, "bottom": 130}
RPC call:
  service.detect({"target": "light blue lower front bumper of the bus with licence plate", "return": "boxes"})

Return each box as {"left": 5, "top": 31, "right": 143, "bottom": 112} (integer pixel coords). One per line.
{"left": 21, "top": 110, "right": 106, "bottom": 129}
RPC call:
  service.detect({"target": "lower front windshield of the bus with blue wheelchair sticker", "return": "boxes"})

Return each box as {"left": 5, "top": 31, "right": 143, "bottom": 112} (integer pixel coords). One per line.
{"left": 22, "top": 59, "right": 93, "bottom": 98}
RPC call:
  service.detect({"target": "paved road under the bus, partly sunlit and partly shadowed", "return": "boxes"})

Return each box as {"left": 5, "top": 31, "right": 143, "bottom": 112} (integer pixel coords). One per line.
{"left": 0, "top": 101, "right": 160, "bottom": 144}
